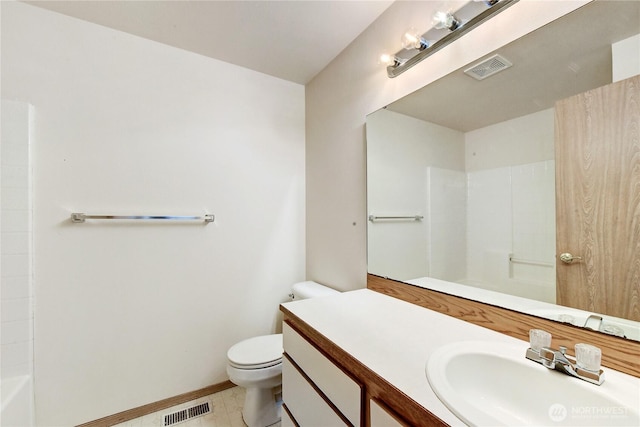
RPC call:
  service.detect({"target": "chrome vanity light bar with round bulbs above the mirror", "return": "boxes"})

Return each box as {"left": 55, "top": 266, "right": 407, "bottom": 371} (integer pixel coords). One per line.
{"left": 380, "top": 0, "right": 518, "bottom": 78}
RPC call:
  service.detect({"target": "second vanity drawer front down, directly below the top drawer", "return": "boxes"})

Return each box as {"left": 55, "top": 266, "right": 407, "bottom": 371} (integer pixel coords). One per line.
{"left": 282, "top": 357, "right": 347, "bottom": 427}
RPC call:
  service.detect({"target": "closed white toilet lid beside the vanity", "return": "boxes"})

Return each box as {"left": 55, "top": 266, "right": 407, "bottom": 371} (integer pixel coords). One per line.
{"left": 227, "top": 334, "right": 283, "bottom": 369}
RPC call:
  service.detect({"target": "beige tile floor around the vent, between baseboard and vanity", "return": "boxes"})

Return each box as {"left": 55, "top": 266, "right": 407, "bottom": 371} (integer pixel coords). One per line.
{"left": 114, "top": 387, "right": 280, "bottom": 427}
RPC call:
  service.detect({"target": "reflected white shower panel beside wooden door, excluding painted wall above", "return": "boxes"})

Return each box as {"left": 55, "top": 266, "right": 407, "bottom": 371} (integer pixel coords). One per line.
{"left": 467, "top": 160, "right": 555, "bottom": 302}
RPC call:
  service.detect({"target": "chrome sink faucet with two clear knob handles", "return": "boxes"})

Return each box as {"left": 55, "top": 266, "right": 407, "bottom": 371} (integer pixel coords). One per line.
{"left": 526, "top": 335, "right": 604, "bottom": 385}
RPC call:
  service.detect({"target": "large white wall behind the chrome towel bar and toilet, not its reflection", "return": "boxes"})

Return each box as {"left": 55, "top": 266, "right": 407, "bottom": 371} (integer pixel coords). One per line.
{"left": 2, "top": 2, "right": 305, "bottom": 426}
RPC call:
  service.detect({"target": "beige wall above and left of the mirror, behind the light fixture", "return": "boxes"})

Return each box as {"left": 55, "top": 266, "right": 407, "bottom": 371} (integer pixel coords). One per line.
{"left": 306, "top": 0, "right": 588, "bottom": 290}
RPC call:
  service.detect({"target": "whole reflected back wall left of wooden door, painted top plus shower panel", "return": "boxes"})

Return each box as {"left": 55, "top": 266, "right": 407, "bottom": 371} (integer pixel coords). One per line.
{"left": 465, "top": 109, "right": 555, "bottom": 302}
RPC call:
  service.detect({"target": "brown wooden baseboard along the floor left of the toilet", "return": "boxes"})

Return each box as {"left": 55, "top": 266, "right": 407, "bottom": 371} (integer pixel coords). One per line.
{"left": 77, "top": 381, "right": 235, "bottom": 427}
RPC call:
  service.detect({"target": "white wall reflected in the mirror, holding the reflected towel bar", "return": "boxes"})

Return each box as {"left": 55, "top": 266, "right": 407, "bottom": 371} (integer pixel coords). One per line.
{"left": 367, "top": 110, "right": 464, "bottom": 280}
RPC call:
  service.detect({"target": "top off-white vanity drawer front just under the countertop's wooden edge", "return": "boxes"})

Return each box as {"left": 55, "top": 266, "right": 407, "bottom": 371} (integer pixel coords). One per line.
{"left": 282, "top": 323, "right": 362, "bottom": 426}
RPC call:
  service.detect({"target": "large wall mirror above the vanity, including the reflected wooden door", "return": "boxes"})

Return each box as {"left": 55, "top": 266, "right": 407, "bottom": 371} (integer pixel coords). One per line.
{"left": 366, "top": 1, "right": 640, "bottom": 340}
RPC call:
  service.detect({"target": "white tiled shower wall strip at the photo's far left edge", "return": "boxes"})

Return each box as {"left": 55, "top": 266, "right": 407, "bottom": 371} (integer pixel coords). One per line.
{"left": 0, "top": 100, "right": 33, "bottom": 379}
